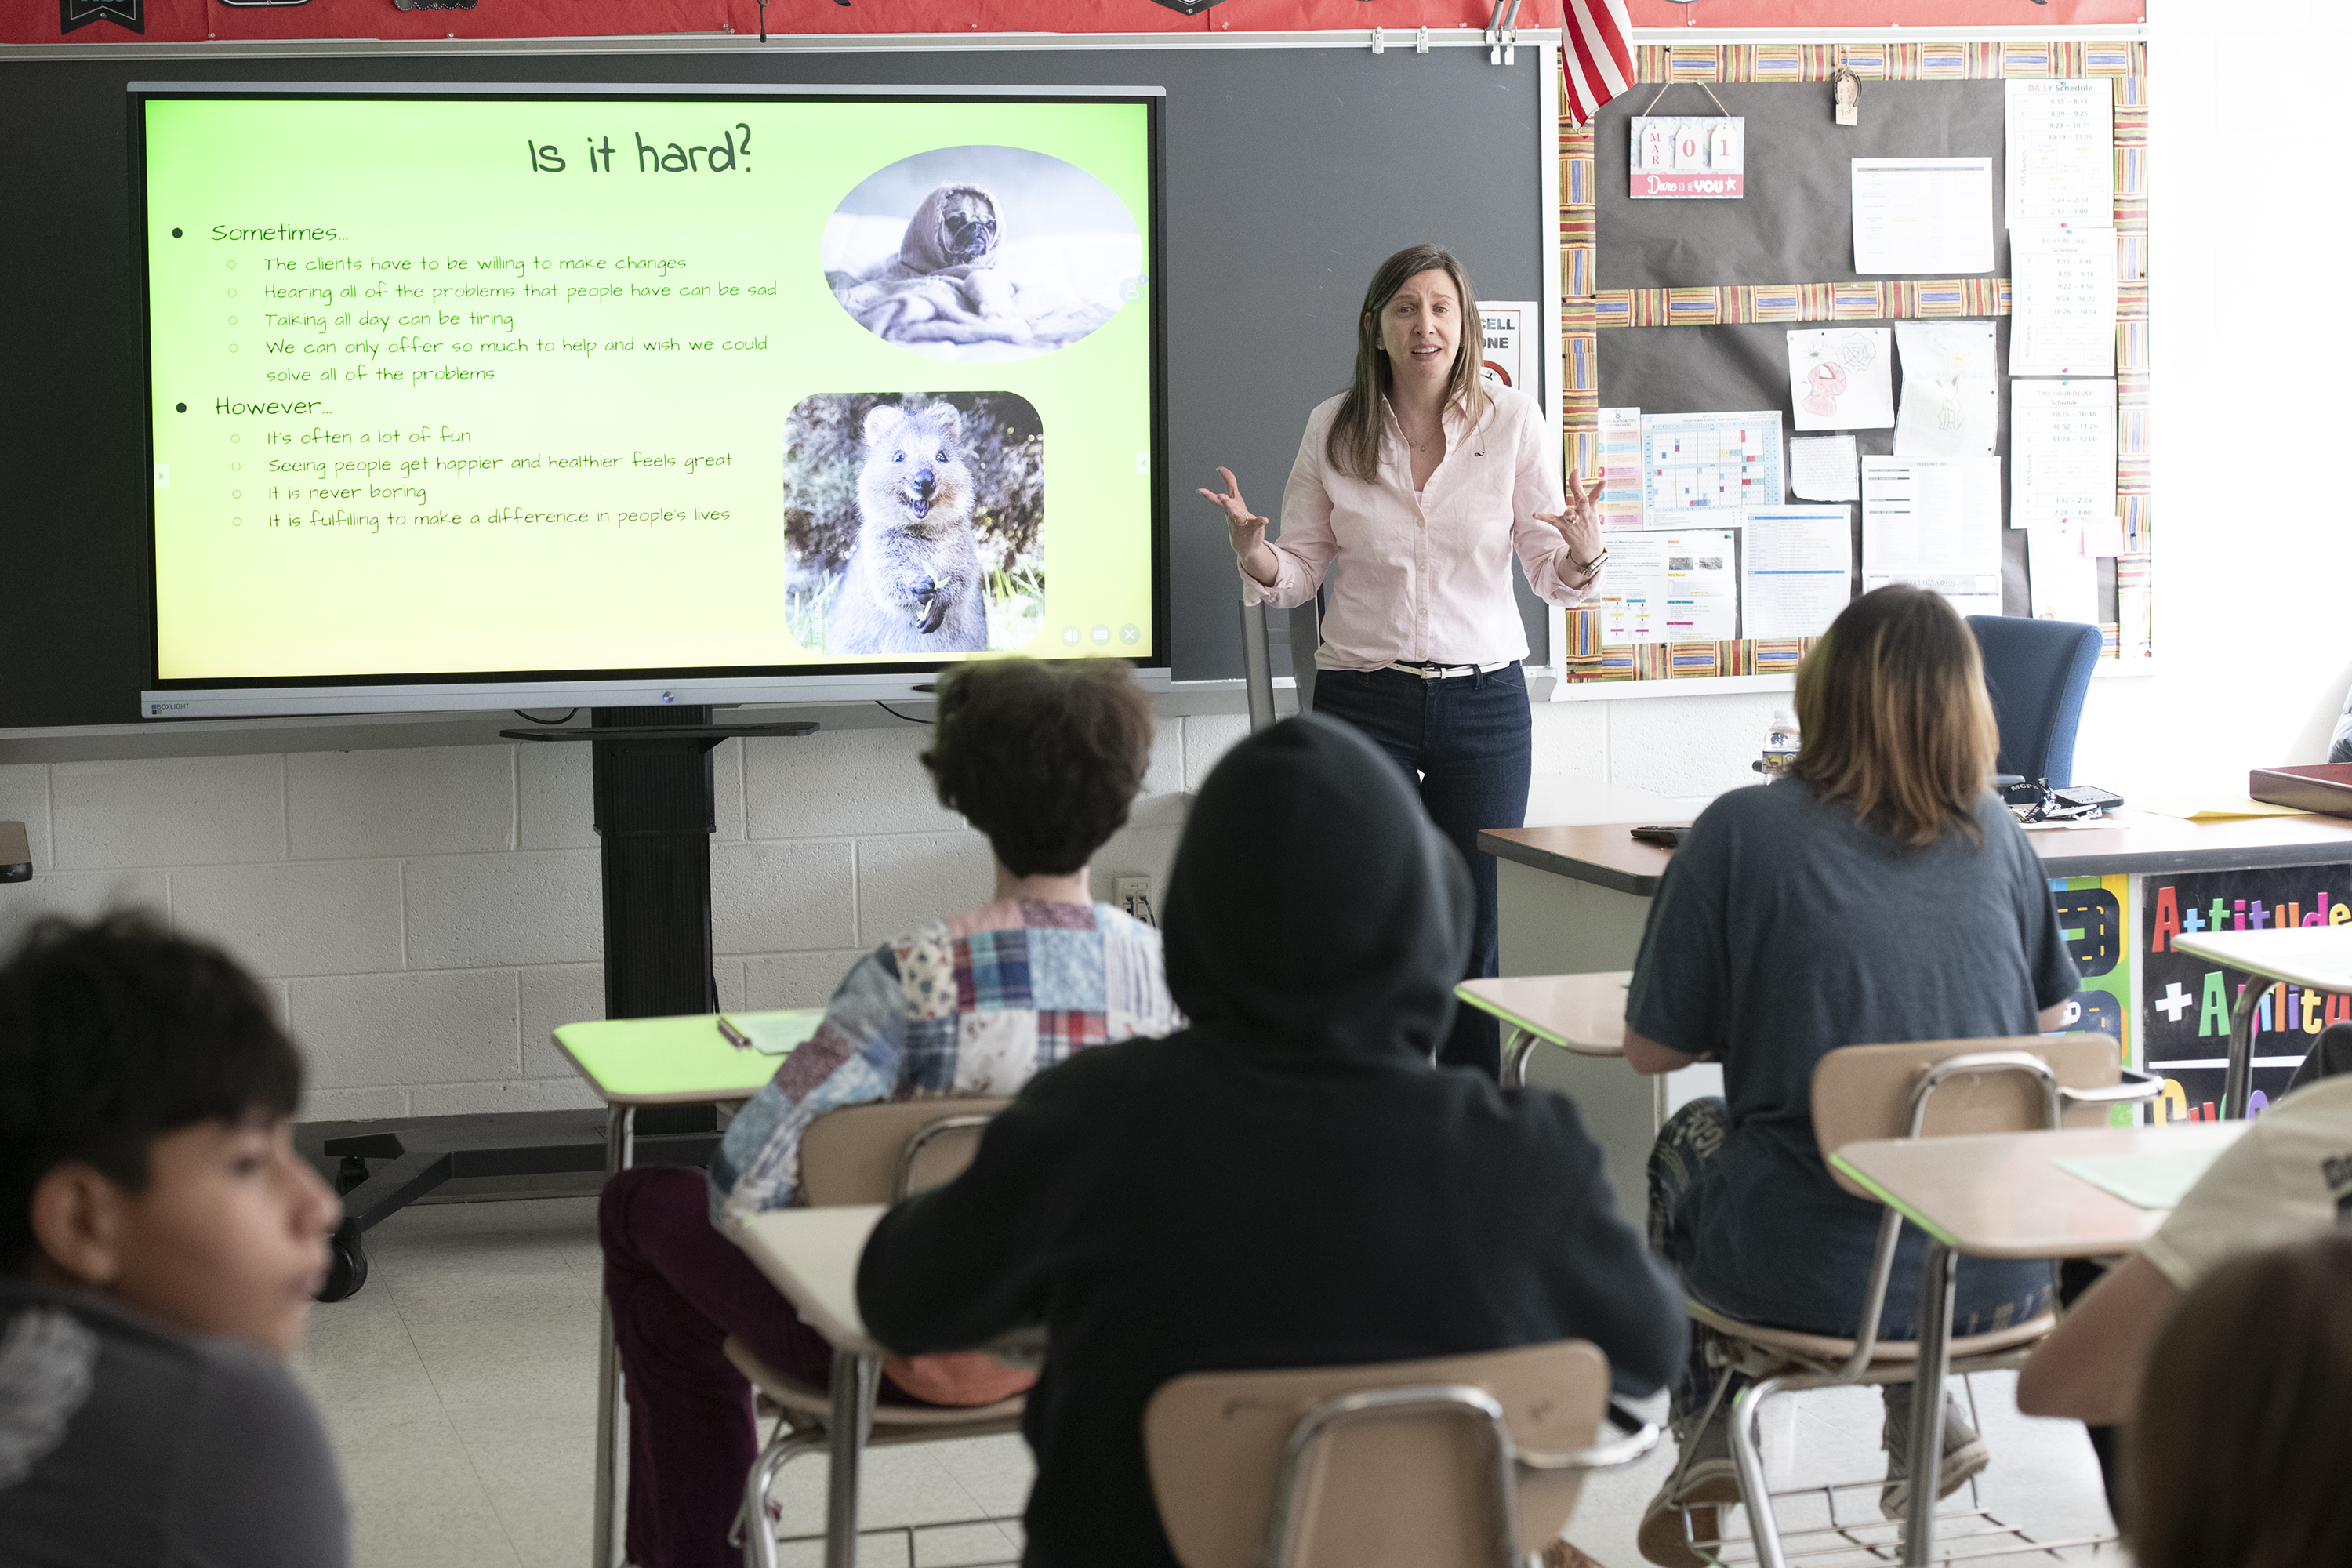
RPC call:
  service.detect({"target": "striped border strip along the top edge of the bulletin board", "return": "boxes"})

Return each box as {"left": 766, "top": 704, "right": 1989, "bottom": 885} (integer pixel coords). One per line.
{"left": 1632, "top": 40, "right": 2147, "bottom": 82}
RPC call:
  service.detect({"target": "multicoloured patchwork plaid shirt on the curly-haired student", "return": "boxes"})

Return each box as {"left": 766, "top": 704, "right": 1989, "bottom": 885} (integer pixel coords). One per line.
{"left": 710, "top": 898, "right": 1183, "bottom": 1225}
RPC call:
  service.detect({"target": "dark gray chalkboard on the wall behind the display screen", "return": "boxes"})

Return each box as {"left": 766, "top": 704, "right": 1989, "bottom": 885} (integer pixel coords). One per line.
{"left": 0, "top": 47, "right": 1555, "bottom": 729}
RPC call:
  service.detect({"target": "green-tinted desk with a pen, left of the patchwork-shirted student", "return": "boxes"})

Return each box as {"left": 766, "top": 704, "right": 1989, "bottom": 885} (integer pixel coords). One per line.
{"left": 555, "top": 1008, "right": 821, "bottom": 1568}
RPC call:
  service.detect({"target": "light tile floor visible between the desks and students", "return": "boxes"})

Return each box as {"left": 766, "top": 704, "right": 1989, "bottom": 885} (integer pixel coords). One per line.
{"left": 296, "top": 1196, "right": 2124, "bottom": 1568}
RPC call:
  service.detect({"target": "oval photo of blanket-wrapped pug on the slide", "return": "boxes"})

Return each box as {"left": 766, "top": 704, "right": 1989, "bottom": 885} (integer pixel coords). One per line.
{"left": 821, "top": 146, "right": 1143, "bottom": 362}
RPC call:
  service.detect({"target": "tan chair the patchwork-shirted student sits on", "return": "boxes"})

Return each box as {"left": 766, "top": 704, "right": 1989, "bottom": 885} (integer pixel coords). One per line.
{"left": 724, "top": 1095, "right": 1025, "bottom": 1568}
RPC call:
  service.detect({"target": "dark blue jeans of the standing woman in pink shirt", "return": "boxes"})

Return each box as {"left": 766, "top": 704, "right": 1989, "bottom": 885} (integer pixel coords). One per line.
{"left": 1315, "top": 666, "right": 1534, "bottom": 1076}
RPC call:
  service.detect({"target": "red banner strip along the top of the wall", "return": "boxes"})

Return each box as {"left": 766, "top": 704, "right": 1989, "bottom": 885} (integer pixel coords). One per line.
{"left": 13, "top": 0, "right": 2145, "bottom": 47}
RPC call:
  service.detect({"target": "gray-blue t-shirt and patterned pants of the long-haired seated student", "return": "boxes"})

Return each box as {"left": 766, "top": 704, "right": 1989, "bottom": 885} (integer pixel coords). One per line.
{"left": 1625, "top": 781, "right": 2077, "bottom": 1338}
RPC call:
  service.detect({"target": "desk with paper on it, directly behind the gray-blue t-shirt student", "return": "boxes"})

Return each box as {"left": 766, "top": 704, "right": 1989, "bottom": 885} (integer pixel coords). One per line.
{"left": 1830, "top": 1121, "right": 2246, "bottom": 1563}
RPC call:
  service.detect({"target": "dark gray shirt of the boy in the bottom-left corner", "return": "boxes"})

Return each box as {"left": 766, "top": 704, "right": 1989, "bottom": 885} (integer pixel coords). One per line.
{"left": 0, "top": 1274, "right": 346, "bottom": 1568}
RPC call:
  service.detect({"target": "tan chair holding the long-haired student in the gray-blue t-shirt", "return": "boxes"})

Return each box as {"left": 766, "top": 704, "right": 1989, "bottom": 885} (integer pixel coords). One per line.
{"left": 1675, "top": 1034, "right": 2161, "bottom": 1568}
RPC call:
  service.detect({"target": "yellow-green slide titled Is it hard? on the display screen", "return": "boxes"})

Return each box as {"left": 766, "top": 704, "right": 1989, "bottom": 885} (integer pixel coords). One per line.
{"left": 143, "top": 94, "right": 1157, "bottom": 682}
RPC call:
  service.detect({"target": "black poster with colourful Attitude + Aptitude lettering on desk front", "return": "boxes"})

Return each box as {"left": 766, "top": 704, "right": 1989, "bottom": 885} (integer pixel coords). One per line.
{"left": 2145, "top": 865, "right": 2352, "bottom": 1121}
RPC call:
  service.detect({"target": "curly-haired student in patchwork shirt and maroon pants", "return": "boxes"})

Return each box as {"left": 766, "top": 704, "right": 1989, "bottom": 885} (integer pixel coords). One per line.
{"left": 600, "top": 659, "right": 1181, "bottom": 1568}
